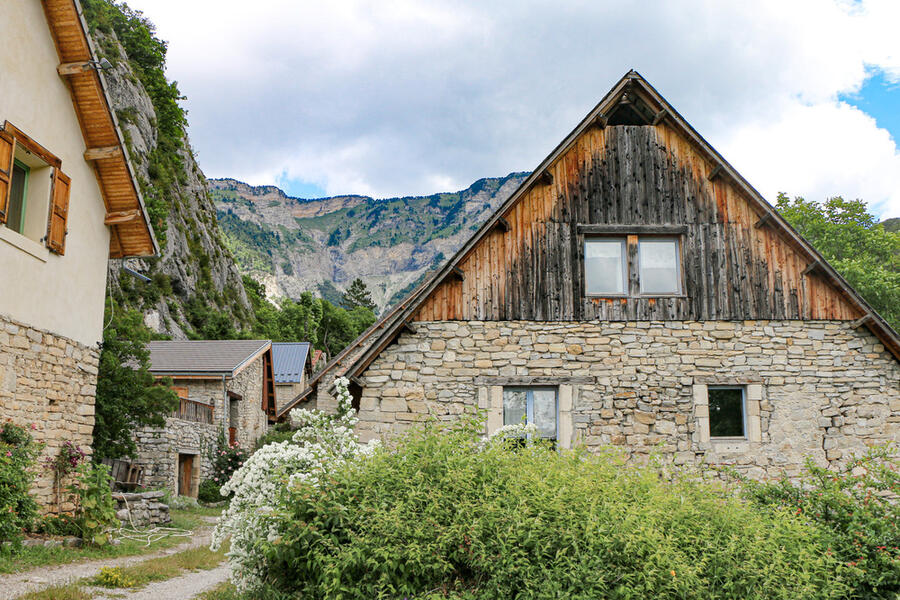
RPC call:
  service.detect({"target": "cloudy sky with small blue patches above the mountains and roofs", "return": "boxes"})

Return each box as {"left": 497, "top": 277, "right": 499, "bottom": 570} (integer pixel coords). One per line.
{"left": 128, "top": 0, "right": 900, "bottom": 217}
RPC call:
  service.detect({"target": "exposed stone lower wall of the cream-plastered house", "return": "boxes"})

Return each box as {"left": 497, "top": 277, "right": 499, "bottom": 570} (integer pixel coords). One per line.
{"left": 0, "top": 315, "right": 100, "bottom": 512}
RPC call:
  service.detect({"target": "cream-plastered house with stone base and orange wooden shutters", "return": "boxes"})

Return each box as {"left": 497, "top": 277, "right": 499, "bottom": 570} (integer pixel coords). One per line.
{"left": 0, "top": 0, "right": 158, "bottom": 511}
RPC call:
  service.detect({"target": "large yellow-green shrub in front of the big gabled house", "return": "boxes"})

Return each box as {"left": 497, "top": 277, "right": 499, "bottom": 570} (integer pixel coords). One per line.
{"left": 261, "top": 422, "right": 848, "bottom": 599}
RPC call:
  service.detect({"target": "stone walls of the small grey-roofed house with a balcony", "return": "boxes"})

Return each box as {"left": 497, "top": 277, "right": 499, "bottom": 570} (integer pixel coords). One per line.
{"left": 134, "top": 357, "right": 268, "bottom": 495}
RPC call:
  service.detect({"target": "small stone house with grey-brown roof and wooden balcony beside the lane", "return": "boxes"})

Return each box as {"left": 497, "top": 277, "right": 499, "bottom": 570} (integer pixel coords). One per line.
{"left": 133, "top": 340, "right": 276, "bottom": 497}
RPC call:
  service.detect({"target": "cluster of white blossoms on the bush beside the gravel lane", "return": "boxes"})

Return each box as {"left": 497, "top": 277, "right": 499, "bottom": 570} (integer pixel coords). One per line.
{"left": 212, "top": 377, "right": 375, "bottom": 591}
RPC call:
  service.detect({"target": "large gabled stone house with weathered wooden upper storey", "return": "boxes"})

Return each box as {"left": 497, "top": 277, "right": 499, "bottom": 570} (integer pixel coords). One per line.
{"left": 279, "top": 71, "right": 900, "bottom": 478}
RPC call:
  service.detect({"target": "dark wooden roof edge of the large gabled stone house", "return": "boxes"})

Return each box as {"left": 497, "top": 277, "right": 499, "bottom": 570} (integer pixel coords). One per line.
{"left": 334, "top": 70, "right": 900, "bottom": 376}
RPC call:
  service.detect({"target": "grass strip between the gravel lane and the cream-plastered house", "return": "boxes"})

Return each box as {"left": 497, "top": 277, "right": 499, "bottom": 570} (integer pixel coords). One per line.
{"left": 0, "top": 507, "right": 222, "bottom": 576}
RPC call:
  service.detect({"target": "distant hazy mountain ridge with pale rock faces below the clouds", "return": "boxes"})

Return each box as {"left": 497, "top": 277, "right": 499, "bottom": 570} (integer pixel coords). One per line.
{"left": 209, "top": 173, "right": 528, "bottom": 309}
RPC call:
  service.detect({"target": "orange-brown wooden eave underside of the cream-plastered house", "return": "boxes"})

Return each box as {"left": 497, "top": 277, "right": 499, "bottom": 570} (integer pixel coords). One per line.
{"left": 41, "top": 0, "right": 159, "bottom": 258}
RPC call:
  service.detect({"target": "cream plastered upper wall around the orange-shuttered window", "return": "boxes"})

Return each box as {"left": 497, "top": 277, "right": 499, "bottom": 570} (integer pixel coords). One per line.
{"left": 0, "top": 0, "right": 109, "bottom": 346}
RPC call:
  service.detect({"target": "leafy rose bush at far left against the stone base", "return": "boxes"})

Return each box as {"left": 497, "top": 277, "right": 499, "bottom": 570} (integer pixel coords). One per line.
{"left": 0, "top": 421, "right": 40, "bottom": 544}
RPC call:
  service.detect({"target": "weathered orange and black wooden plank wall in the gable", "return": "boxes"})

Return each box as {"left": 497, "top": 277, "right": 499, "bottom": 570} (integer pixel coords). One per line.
{"left": 414, "top": 122, "right": 861, "bottom": 321}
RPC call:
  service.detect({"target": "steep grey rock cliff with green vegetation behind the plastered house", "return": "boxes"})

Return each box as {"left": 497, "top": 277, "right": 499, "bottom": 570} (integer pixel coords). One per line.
{"left": 82, "top": 0, "right": 253, "bottom": 339}
